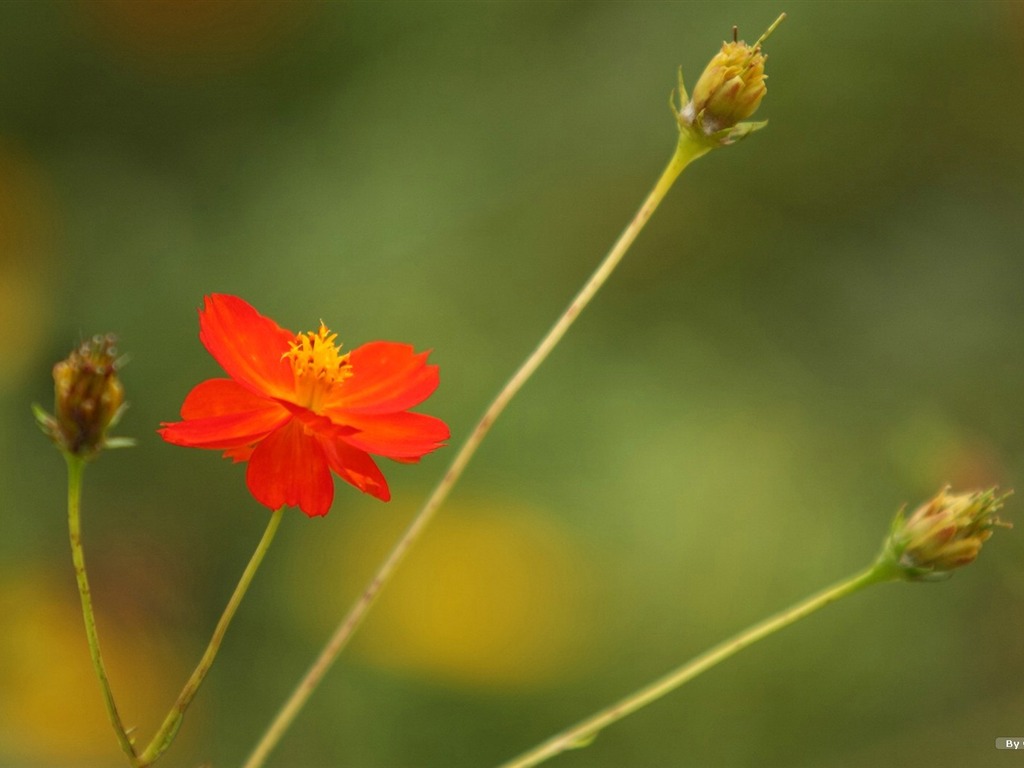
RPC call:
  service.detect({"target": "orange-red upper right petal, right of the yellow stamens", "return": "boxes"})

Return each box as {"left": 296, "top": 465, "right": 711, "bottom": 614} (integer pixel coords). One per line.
{"left": 327, "top": 341, "right": 438, "bottom": 421}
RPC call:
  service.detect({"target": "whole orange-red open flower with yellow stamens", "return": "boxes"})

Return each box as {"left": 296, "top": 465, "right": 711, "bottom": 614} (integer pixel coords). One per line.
{"left": 159, "top": 294, "right": 449, "bottom": 516}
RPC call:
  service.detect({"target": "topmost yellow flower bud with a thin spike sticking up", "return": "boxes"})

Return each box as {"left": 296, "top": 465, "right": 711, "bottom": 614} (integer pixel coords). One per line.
{"left": 674, "top": 13, "right": 785, "bottom": 145}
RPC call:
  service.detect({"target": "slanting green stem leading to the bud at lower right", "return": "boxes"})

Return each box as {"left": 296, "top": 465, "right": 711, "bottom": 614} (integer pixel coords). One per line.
{"left": 501, "top": 560, "right": 897, "bottom": 768}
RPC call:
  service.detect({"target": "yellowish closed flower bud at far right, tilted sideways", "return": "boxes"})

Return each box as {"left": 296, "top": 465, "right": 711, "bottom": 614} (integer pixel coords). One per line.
{"left": 883, "top": 487, "right": 1011, "bottom": 581}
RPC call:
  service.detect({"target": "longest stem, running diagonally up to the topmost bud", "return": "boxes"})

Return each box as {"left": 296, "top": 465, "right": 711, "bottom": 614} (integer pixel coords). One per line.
{"left": 244, "top": 134, "right": 712, "bottom": 768}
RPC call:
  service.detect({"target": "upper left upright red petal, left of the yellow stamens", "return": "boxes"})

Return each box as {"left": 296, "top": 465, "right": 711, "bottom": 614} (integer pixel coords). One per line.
{"left": 199, "top": 294, "right": 295, "bottom": 397}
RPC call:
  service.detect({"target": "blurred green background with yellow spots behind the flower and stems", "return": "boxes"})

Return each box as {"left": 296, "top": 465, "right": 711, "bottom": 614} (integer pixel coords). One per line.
{"left": 0, "top": 0, "right": 1024, "bottom": 768}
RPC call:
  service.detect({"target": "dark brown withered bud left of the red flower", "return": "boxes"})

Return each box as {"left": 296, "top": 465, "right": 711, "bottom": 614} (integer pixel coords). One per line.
{"left": 35, "top": 335, "right": 125, "bottom": 457}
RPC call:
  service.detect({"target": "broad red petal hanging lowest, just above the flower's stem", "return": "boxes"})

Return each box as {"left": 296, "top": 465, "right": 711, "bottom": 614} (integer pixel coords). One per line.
{"left": 246, "top": 420, "right": 334, "bottom": 517}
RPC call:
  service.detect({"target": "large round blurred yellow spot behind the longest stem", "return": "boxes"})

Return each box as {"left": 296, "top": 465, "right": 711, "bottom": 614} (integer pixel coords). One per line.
{"left": 292, "top": 503, "right": 599, "bottom": 688}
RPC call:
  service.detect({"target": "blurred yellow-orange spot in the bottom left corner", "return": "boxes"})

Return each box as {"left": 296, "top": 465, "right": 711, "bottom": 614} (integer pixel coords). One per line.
{"left": 0, "top": 571, "right": 181, "bottom": 766}
